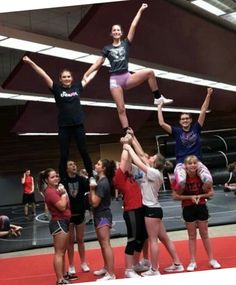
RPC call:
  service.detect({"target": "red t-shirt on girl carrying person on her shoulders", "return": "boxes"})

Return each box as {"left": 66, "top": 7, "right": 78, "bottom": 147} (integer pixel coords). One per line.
{"left": 181, "top": 175, "right": 206, "bottom": 207}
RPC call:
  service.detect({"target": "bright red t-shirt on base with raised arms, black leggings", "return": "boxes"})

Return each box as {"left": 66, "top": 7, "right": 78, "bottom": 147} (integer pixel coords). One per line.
{"left": 113, "top": 168, "right": 142, "bottom": 211}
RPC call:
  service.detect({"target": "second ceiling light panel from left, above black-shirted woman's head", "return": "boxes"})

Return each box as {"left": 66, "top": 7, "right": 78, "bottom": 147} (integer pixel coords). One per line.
{"left": 39, "top": 47, "right": 88, "bottom": 59}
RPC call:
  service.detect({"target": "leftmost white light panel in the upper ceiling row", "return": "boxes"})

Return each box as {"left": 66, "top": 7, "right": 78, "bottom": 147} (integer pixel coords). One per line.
{"left": 0, "top": 38, "right": 51, "bottom": 52}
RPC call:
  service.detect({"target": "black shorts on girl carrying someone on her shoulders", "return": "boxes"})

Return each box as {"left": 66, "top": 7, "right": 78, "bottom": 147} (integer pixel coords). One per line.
{"left": 183, "top": 204, "right": 209, "bottom": 223}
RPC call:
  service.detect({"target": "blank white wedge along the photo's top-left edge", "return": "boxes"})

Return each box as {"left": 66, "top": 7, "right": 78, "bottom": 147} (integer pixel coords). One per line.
{"left": 0, "top": 0, "right": 127, "bottom": 13}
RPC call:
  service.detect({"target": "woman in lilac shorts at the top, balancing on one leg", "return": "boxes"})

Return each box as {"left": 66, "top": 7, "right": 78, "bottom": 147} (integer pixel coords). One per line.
{"left": 84, "top": 4, "right": 173, "bottom": 133}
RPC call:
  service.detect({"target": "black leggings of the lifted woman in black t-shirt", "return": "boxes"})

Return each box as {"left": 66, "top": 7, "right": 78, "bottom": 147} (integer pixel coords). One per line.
{"left": 58, "top": 124, "right": 93, "bottom": 179}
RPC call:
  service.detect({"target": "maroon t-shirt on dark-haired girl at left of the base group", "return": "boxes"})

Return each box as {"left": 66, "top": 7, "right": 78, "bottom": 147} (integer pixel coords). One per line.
{"left": 44, "top": 187, "right": 71, "bottom": 221}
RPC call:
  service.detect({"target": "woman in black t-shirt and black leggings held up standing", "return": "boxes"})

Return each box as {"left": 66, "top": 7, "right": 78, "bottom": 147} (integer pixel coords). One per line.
{"left": 23, "top": 56, "right": 96, "bottom": 186}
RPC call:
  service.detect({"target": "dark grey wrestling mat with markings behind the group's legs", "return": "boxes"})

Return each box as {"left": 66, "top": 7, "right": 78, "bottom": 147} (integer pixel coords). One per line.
{"left": 0, "top": 187, "right": 236, "bottom": 253}
